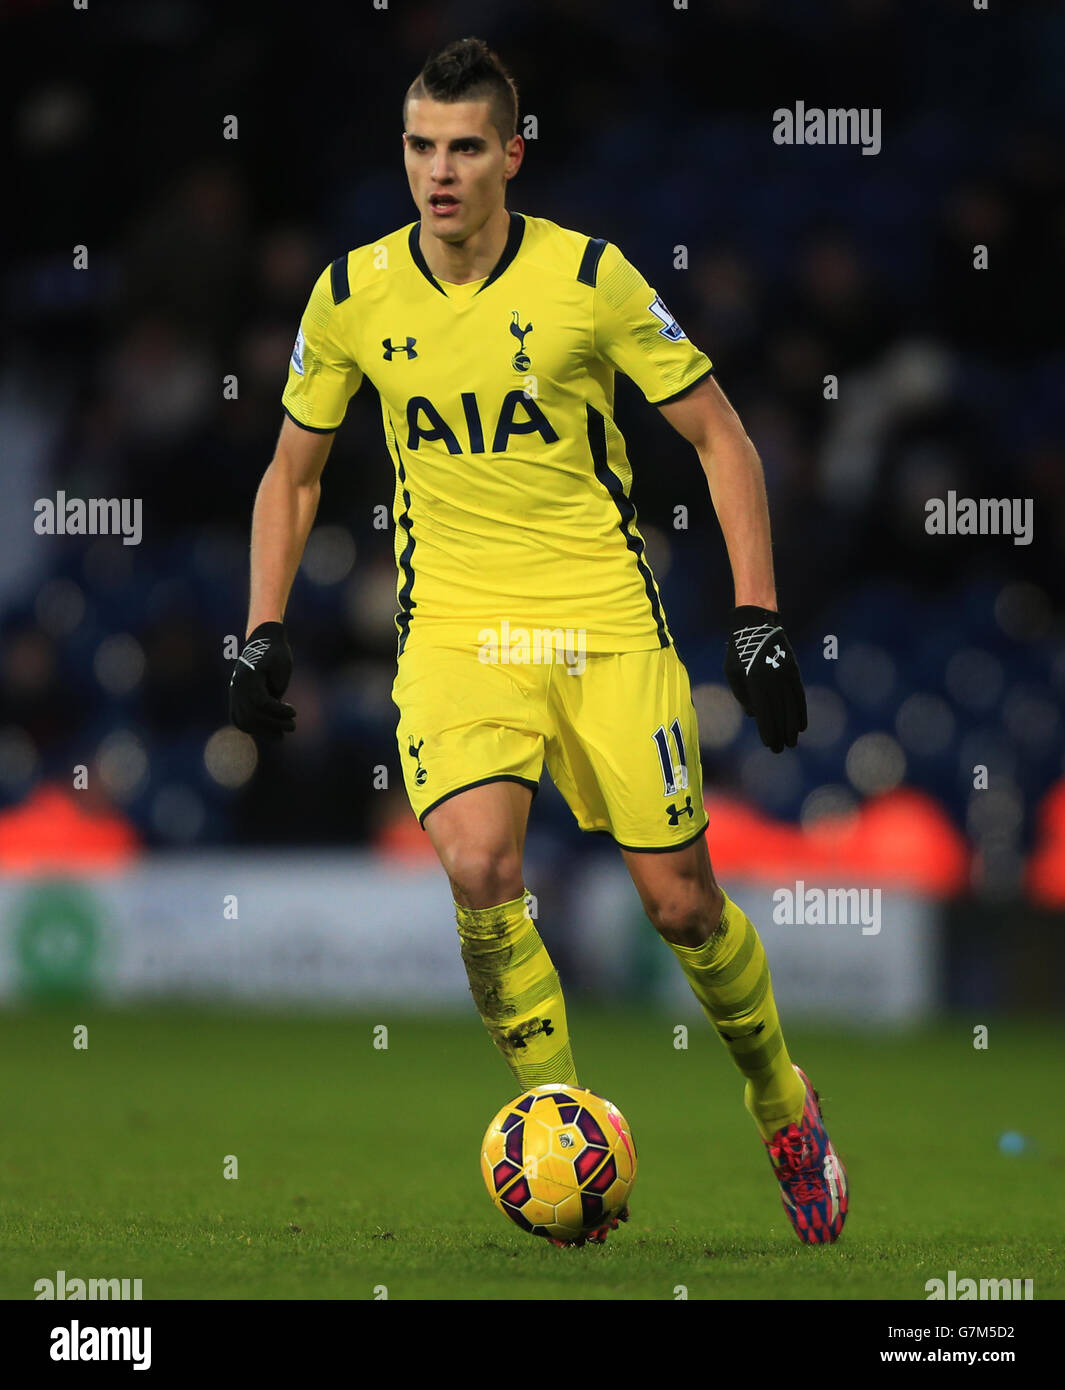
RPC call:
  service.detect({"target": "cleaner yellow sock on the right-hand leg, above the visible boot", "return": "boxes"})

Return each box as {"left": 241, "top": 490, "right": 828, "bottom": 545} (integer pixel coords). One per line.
{"left": 669, "top": 892, "right": 805, "bottom": 1138}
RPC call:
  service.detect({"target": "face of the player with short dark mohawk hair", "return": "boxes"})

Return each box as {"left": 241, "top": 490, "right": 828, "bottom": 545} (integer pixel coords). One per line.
{"left": 403, "top": 97, "right": 523, "bottom": 242}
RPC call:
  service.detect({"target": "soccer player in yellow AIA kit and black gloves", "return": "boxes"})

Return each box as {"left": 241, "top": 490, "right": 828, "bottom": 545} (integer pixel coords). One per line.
{"left": 231, "top": 39, "right": 847, "bottom": 1244}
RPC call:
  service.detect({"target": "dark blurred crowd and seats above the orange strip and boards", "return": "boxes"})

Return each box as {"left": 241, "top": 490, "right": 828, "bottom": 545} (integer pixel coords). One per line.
{"left": 0, "top": 0, "right": 1065, "bottom": 884}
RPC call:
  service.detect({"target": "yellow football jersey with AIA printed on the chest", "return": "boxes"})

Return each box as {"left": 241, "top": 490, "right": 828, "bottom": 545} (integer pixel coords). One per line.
{"left": 282, "top": 213, "right": 712, "bottom": 653}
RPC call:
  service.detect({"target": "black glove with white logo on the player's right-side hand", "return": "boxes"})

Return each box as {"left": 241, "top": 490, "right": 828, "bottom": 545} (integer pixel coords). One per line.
{"left": 724, "top": 605, "right": 806, "bottom": 753}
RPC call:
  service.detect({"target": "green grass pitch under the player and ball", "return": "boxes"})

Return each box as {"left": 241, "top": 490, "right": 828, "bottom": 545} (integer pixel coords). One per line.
{"left": 0, "top": 1002, "right": 1065, "bottom": 1300}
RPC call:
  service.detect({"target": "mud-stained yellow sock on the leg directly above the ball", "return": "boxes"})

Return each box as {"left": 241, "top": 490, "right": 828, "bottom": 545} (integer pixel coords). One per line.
{"left": 455, "top": 894, "right": 578, "bottom": 1091}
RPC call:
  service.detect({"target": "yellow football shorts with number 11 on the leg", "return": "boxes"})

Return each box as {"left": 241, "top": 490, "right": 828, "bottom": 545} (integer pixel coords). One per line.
{"left": 392, "top": 627, "right": 708, "bottom": 851}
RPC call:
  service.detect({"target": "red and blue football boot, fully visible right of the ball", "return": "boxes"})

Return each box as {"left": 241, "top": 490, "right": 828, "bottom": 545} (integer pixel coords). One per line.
{"left": 762, "top": 1063, "right": 847, "bottom": 1245}
